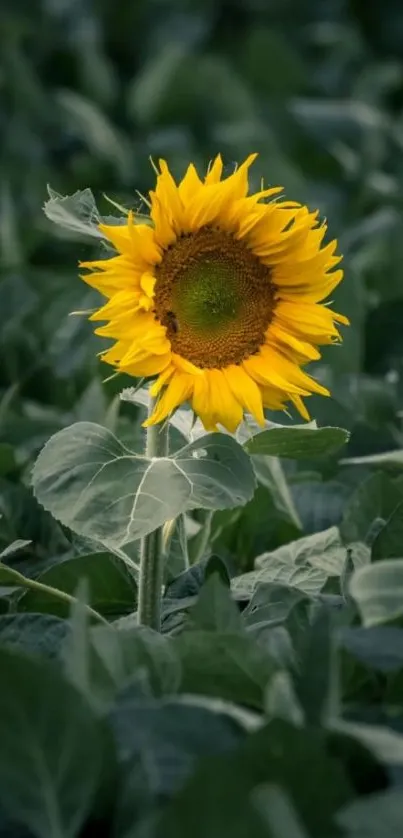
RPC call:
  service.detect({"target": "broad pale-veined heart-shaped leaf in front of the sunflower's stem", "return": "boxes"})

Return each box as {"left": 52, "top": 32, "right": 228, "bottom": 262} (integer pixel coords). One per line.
{"left": 33, "top": 422, "right": 255, "bottom": 547}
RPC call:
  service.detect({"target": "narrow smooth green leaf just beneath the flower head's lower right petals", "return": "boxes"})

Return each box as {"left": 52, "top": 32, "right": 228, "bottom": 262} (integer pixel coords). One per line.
{"left": 244, "top": 427, "right": 349, "bottom": 460}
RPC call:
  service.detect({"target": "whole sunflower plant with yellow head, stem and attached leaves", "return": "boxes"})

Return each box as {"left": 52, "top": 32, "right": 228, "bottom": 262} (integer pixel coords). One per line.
{"left": 33, "top": 154, "right": 348, "bottom": 629}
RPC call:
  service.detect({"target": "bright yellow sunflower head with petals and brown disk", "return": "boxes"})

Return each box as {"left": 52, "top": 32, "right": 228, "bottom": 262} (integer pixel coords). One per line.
{"left": 81, "top": 154, "right": 348, "bottom": 432}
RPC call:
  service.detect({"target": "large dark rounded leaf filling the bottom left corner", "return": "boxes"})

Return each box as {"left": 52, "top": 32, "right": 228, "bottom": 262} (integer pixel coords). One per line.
{"left": 0, "top": 649, "right": 105, "bottom": 838}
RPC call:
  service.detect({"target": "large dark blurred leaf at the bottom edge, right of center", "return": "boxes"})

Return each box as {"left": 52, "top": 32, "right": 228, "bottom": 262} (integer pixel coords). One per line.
{"left": 157, "top": 719, "right": 353, "bottom": 838}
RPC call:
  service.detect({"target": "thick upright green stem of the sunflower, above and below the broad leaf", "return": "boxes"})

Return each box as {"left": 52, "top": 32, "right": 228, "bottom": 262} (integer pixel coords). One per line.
{"left": 137, "top": 397, "right": 169, "bottom": 631}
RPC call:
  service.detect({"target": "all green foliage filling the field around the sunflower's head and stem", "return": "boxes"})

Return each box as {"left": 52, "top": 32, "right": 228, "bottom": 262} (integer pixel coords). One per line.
{"left": 0, "top": 0, "right": 403, "bottom": 838}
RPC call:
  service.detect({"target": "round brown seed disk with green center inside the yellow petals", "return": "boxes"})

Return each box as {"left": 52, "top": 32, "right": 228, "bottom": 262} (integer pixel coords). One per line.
{"left": 154, "top": 227, "right": 275, "bottom": 368}
